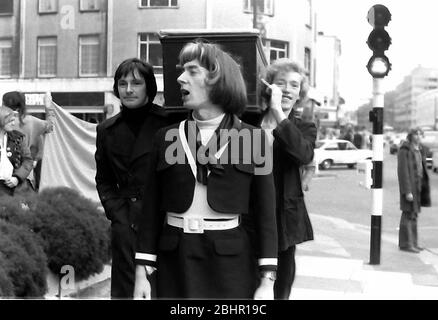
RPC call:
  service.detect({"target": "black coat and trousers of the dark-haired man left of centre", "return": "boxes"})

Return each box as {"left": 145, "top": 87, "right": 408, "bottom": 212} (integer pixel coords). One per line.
{"left": 95, "top": 104, "right": 168, "bottom": 298}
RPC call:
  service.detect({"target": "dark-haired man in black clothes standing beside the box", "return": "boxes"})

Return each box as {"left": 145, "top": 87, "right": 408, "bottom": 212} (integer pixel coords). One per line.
{"left": 95, "top": 58, "right": 168, "bottom": 298}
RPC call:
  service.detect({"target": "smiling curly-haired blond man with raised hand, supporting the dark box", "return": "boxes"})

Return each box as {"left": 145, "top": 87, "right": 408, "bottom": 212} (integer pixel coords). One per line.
{"left": 261, "top": 59, "right": 317, "bottom": 300}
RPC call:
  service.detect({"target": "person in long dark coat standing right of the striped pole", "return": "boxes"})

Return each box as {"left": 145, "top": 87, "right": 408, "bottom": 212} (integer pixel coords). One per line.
{"left": 397, "top": 129, "right": 431, "bottom": 253}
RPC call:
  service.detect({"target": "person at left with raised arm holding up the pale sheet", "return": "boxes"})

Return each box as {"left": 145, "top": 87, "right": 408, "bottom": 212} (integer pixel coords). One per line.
{"left": 3, "top": 91, "right": 54, "bottom": 191}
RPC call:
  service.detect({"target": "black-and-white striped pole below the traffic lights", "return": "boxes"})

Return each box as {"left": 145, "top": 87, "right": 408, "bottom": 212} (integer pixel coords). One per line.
{"left": 370, "top": 78, "right": 384, "bottom": 265}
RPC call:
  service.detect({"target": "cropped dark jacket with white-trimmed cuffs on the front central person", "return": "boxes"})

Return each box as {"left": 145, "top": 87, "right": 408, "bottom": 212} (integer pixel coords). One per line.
{"left": 137, "top": 117, "right": 277, "bottom": 264}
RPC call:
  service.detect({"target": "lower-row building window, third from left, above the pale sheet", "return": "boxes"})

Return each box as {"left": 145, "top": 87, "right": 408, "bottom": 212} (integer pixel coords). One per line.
{"left": 79, "top": 36, "right": 100, "bottom": 77}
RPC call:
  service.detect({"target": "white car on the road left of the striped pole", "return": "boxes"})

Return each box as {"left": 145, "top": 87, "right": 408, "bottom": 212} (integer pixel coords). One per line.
{"left": 314, "top": 139, "right": 373, "bottom": 169}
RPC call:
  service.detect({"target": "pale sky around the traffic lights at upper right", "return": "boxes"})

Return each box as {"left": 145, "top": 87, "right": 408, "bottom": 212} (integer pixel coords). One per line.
{"left": 313, "top": 0, "right": 438, "bottom": 110}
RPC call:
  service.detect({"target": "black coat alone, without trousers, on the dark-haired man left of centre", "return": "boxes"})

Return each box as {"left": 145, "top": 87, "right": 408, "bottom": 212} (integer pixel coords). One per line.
{"left": 95, "top": 104, "right": 168, "bottom": 229}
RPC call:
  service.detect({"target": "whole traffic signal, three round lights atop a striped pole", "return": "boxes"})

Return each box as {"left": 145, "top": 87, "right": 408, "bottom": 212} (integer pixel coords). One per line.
{"left": 367, "top": 4, "right": 391, "bottom": 264}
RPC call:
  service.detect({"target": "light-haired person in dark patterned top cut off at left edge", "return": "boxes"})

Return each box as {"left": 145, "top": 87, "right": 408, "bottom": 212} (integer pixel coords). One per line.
{"left": 0, "top": 106, "right": 32, "bottom": 196}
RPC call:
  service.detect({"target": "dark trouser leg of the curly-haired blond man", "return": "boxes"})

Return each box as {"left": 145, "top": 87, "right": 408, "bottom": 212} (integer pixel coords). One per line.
{"left": 274, "top": 245, "right": 296, "bottom": 300}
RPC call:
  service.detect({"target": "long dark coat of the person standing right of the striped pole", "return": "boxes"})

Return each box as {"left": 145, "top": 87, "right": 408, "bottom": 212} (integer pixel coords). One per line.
{"left": 397, "top": 141, "right": 431, "bottom": 212}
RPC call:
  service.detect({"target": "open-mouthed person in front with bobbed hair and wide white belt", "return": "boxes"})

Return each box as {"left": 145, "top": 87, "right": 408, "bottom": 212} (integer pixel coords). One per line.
{"left": 136, "top": 40, "right": 277, "bottom": 299}
